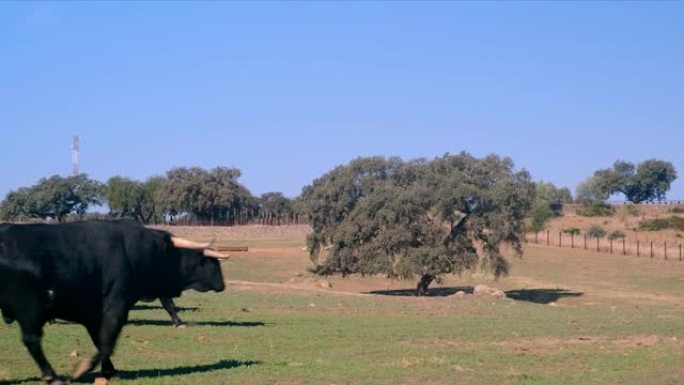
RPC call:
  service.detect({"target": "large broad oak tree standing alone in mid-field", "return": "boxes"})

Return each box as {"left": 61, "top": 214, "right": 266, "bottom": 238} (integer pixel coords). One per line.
{"left": 301, "top": 153, "right": 534, "bottom": 295}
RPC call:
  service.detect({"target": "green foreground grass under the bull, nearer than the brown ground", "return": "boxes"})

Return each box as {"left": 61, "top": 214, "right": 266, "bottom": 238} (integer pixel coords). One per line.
{"left": 5, "top": 293, "right": 684, "bottom": 384}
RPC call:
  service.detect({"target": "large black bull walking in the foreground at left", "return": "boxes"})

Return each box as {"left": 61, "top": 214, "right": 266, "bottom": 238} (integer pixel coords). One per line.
{"left": 0, "top": 221, "right": 225, "bottom": 384}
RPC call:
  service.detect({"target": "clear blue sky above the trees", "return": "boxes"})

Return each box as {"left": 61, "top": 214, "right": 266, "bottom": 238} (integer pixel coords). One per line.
{"left": 0, "top": 2, "right": 684, "bottom": 199}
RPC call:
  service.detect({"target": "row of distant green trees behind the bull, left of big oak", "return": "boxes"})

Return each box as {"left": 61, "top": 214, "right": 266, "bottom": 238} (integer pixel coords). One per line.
{"left": 0, "top": 167, "right": 304, "bottom": 225}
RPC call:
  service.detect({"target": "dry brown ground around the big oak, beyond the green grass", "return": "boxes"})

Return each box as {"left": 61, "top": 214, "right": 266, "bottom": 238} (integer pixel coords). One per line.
{"left": 159, "top": 225, "right": 684, "bottom": 308}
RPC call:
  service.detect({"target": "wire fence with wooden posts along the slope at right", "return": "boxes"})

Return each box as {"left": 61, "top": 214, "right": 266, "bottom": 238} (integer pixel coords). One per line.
{"left": 525, "top": 230, "right": 684, "bottom": 261}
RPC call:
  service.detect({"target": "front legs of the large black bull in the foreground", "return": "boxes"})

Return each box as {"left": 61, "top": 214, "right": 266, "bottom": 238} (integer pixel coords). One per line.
{"left": 72, "top": 301, "right": 130, "bottom": 379}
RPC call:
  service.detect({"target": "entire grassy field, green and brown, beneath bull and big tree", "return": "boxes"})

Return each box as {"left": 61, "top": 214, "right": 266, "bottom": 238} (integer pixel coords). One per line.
{"left": 0, "top": 228, "right": 684, "bottom": 385}
